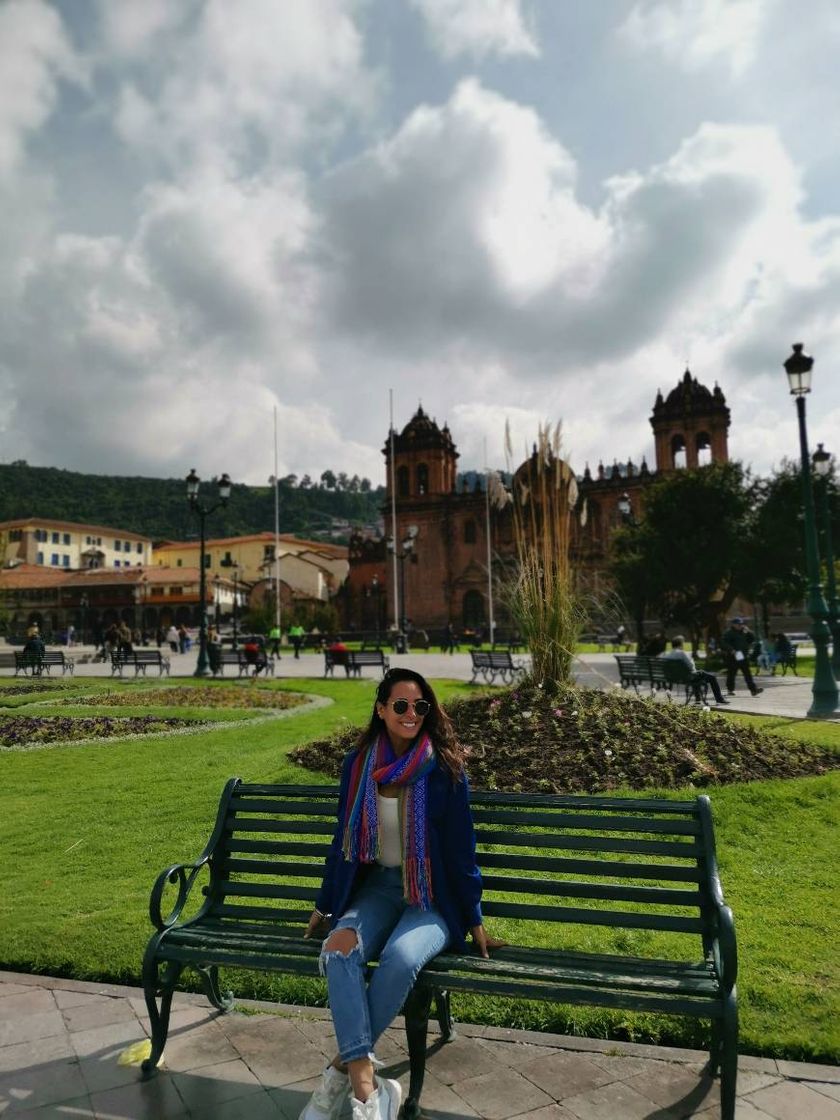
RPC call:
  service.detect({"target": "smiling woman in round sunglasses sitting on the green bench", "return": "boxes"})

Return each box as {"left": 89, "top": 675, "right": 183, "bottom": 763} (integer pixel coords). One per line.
{"left": 300, "top": 669, "right": 501, "bottom": 1120}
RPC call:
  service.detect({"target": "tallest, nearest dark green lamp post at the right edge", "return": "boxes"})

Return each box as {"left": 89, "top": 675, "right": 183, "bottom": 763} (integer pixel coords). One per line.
{"left": 784, "top": 343, "right": 838, "bottom": 716}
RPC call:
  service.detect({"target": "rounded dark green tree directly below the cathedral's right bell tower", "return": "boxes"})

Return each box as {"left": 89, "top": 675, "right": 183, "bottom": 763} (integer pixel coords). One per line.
{"left": 610, "top": 463, "right": 752, "bottom": 645}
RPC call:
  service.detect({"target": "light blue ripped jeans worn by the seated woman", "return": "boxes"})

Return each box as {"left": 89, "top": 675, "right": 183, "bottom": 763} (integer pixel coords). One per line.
{"left": 320, "top": 865, "right": 449, "bottom": 1062}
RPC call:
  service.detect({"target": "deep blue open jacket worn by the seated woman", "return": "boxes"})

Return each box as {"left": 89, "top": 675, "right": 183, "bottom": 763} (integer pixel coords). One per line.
{"left": 315, "top": 750, "right": 482, "bottom": 951}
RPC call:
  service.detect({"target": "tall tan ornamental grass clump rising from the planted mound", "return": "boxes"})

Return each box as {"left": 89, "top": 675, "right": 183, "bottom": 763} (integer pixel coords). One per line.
{"left": 505, "top": 422, "right": 586, "bottom": 684}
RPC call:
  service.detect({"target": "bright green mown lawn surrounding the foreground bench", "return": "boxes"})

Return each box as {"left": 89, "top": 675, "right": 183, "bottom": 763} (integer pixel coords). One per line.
{"left": 0, "top": 680, "right": 840, "bottom": 1061}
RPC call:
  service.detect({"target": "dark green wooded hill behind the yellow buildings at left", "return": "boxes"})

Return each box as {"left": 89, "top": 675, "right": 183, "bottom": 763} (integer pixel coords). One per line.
{"left": 0, "top": 461, "right": 385, "bottom": 541}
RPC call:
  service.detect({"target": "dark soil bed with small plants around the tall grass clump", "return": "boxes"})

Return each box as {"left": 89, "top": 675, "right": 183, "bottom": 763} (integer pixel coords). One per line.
{"left": 291, "top": 685, "right": 840, "bottom": 793}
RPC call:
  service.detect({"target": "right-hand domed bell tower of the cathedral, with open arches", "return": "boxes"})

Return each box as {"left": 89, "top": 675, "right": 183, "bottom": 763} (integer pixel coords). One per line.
{"left": 651, "top": 370, "right": 729, "bottom": 470}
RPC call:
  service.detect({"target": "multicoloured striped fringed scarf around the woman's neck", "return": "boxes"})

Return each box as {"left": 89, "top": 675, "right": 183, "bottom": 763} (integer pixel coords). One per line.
{"left": 342, "top": 732, "right": 436, "bottom": 909}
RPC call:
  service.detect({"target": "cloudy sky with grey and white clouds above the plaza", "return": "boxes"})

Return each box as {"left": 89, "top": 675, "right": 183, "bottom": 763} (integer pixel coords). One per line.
{"left": 0, "top": 0, "right": 840, "bottom": 483}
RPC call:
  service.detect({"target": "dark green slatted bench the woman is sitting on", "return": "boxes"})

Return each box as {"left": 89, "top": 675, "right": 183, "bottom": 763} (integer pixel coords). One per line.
{"left": 142, "top": 778, "right": 738, "bottom": 1120}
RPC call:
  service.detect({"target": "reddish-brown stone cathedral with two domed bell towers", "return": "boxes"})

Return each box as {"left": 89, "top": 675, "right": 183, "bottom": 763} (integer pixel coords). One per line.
{"left": 345, "top": 370, "right": 729, "bottom": 629}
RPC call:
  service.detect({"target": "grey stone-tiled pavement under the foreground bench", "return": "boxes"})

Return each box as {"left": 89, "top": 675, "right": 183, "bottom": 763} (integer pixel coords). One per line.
{"left": 0, "top": 972, "right": 840, "bottom": 1120}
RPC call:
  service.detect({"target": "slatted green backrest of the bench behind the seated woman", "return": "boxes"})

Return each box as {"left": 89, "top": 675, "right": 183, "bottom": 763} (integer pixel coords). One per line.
{"left": 202, "top": 778, "right": 719, "bottom": 959}
